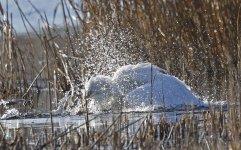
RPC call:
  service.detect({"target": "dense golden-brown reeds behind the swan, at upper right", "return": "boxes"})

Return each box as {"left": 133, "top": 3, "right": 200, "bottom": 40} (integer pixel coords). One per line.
{"left": 76, "top": 0, "right": 241, "bottom": 101}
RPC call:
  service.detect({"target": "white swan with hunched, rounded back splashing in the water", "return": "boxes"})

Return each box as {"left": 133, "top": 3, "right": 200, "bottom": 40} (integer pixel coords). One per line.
{"left": 85, "top": 63, "right": 204, "bottom": 111}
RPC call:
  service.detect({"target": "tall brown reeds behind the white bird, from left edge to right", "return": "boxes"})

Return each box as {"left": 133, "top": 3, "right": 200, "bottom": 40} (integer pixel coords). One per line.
{"left": 0, "top": 0, "right": 241, "bottom": 107}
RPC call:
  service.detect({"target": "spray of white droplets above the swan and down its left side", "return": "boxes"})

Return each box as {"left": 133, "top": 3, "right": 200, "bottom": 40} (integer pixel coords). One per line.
{"left": 60, "top": 23, "right": 148, "bottom": 113}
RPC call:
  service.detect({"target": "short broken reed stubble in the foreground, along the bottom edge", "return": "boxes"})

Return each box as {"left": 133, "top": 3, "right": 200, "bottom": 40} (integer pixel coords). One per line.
{"left": 0, "top": 109, "right": 241, "bottom": 150}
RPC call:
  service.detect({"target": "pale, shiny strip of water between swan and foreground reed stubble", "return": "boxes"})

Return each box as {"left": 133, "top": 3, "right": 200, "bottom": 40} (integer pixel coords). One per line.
{"left": 0, "top": 112, "right": 185, "bottom": 144}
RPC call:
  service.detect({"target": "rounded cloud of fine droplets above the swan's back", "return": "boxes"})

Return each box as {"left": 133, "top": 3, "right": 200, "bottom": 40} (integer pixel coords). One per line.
{"left": 76, "top": 25, "right": 147, "bottom": 77}
